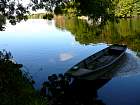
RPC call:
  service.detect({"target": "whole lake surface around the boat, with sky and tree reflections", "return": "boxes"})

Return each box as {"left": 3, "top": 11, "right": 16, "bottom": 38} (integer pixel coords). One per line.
{"left": 0, "top": 17, "right": 140, "bottom": 105}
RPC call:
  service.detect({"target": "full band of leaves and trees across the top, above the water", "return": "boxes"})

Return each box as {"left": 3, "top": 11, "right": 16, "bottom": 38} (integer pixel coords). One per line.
{"left": 0, "top": 0, "right": 140, "bottom": 30}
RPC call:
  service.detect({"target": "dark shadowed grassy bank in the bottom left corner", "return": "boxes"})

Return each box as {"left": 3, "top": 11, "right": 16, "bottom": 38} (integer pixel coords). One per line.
{"left": 0, "top": 52, "right": 47, "bottom": 105}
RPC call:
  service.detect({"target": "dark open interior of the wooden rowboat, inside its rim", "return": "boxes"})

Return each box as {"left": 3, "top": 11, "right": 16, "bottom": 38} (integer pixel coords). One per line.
{"left": 72, "top": 47, "right": 124, "bottom": 70}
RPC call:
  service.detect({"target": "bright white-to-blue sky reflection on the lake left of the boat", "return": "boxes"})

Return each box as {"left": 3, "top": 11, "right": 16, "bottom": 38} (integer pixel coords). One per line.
{"left": 0, "top": 19, "right": 106, "bottom": 87}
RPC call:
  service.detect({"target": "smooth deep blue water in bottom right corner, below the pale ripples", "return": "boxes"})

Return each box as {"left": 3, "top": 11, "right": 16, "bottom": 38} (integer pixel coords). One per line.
{"left": 98, "top": 75, "right": 140, "bottom": 105}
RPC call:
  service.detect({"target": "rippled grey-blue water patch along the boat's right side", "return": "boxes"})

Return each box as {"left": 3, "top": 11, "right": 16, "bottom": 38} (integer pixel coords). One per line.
{"left": 97, "top": 49, "right": 140, "bottom": 78}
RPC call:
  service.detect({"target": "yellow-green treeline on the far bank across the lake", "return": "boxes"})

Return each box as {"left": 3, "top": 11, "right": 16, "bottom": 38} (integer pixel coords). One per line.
{"left": 30, "top": 0, "right": 140, "bottom": 18}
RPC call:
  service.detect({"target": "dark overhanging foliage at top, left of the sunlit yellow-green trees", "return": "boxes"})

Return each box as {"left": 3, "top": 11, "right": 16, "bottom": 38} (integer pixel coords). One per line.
{"left": 78, "top": 0, "right": 114, "bottom": 22}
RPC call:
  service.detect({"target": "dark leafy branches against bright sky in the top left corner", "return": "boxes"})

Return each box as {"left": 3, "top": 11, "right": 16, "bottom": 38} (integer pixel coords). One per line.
{"left": 0, "top": 0, "right": 29, "bottom": 30}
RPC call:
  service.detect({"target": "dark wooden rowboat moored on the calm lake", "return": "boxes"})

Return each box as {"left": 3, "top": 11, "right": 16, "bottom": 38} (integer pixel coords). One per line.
{"left": 65, "top": 44, "right": 127, "bottom": 79}
